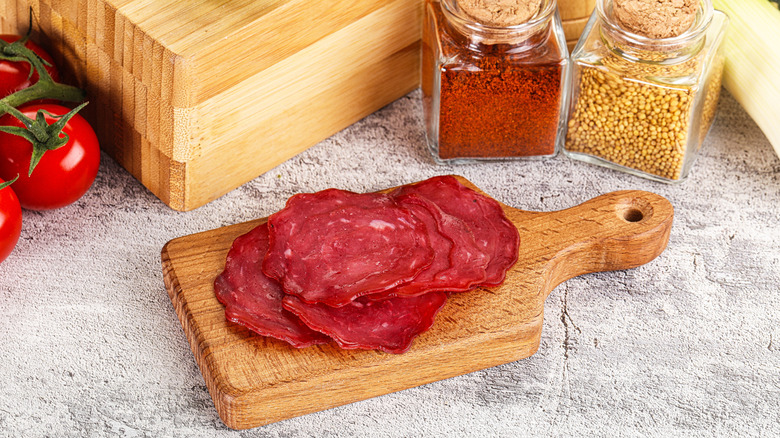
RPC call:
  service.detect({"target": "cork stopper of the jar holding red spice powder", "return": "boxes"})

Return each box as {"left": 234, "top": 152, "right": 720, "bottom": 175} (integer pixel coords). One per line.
{"left": 458, "top": 0, "right": 542, "bottom": 27}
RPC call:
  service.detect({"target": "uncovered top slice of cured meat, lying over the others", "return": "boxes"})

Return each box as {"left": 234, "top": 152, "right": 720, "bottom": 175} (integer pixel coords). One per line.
{"left": 263, "top": 189, "right": 434, "bottom": 307}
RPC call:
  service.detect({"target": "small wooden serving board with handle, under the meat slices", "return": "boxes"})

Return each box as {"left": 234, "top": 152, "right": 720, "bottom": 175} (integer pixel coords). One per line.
{"left": 162, "top": 178, "right": 673, "bottom": 429}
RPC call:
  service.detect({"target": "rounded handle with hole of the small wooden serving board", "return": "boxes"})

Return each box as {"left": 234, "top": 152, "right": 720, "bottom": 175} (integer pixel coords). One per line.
{"left": 510, "top": 190, "right": 674, "bottom": 297}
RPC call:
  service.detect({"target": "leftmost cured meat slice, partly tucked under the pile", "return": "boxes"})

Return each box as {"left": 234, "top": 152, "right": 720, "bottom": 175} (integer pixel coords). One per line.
{"left": 214, "top": 224, "right": 330, "bottom": 348}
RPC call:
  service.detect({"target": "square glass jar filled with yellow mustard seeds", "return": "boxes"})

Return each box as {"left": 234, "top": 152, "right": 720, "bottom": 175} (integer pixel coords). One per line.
{"left": 564, "top": 0, "right": 728, "bottom": 183}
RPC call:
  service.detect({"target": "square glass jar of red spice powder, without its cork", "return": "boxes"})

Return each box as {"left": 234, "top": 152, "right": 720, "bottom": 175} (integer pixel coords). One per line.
{"left": 421, "top": 0, "right": 569, "bottom": 163}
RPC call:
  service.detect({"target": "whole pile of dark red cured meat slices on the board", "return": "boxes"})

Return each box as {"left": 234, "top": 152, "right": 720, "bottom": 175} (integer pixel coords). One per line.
{"left": 214, "top": 176, "right": 520, "bottom": 353}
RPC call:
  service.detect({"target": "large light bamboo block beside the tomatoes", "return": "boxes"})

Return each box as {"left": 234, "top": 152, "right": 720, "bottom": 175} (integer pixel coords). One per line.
{"left": 0, "top": 0, "right": 423, "bottom": 210}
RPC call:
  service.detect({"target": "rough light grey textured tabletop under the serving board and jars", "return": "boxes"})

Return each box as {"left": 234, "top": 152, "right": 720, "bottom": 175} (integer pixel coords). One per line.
{"left": 0, "top": 92, "right": 780, "bottom": 437}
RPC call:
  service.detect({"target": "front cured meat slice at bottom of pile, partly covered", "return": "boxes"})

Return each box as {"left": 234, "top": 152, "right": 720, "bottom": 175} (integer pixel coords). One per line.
{"left": 284, "top": 292, "right": 447, "bottom": 354}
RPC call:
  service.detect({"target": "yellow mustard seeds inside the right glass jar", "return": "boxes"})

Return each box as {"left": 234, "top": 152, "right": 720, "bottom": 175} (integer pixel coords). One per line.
{"left": 566, "top": 45, "right": 721, "bottom": 180}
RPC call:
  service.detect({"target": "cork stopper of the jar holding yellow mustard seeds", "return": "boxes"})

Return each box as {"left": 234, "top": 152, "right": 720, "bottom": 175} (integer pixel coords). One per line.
{"left": 612, "top": 0, "right": 700, "bottom": 38}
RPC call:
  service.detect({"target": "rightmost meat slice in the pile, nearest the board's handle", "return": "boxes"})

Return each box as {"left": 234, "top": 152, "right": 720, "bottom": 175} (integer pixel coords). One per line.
{"left": 392, "top": 175, "right": 520, "bottom": 286}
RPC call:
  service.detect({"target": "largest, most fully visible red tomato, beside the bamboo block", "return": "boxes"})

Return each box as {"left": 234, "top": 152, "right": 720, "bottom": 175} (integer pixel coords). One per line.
{"left": 0, "top": 104, "right": 100, "bottom": 210}
